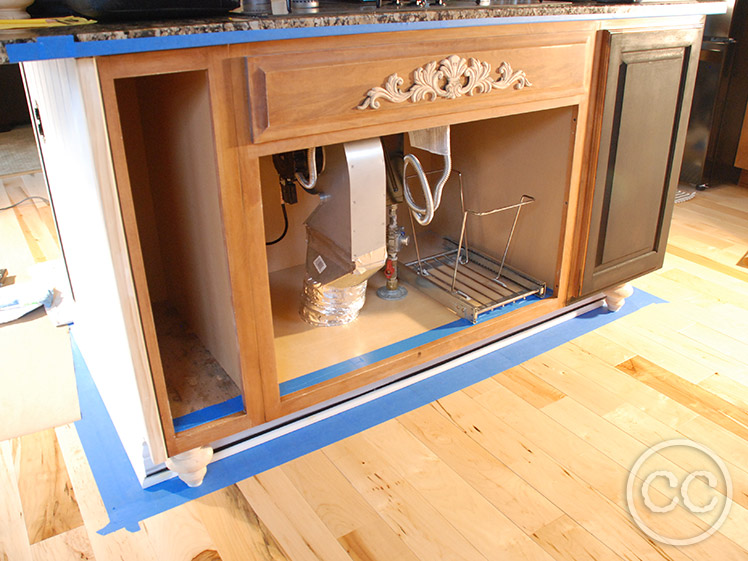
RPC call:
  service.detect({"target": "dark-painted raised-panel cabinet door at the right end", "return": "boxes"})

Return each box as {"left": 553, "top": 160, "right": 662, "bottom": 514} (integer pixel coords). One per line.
{"left": 581, "top": 29, "right": 701, "bottom": 295}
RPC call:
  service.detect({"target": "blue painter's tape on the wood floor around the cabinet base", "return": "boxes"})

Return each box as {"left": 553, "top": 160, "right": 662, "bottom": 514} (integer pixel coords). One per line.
{"left": 73, "top": 290, "right": 665, "bottom": 534}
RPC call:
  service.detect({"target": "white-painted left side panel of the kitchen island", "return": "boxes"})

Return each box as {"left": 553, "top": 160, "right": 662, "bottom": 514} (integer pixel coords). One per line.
{"left": 23, "top": 59, "right": 166, "bottom": 482}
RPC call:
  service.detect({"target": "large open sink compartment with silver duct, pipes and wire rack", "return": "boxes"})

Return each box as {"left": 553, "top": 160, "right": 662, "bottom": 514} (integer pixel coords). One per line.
{"left": 260, "top": 107, "right": 576, "bottom": 399}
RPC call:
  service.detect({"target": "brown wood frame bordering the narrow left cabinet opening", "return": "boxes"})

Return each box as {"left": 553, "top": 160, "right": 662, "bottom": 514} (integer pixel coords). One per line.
{"left": 93, "top": 48, "right": 264, "bottom": 456}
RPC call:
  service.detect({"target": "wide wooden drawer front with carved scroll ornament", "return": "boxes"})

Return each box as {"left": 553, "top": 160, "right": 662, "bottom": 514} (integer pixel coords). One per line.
{"left": 246, "top": 33, "right": 591, "bottom": 143}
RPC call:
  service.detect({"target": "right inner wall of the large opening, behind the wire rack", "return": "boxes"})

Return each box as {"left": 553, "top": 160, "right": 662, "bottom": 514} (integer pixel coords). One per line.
{"left": 432, "top": 107, "right": 576, "bottom": 288}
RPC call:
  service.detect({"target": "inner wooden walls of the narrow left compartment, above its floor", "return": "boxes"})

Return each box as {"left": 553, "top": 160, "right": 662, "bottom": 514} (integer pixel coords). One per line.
{"left": 117, "top": 71, "right": 241, "bottom": 386}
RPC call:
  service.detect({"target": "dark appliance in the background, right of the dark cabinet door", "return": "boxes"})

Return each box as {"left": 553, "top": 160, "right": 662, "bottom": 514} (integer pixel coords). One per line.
{"left": 680, "top": 0, "right": 748, "bottom": 190}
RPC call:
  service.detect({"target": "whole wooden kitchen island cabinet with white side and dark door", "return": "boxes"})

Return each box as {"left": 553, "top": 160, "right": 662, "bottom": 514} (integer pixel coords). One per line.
{"left": 17, "top": 10, "right": 703, "bottom": 484}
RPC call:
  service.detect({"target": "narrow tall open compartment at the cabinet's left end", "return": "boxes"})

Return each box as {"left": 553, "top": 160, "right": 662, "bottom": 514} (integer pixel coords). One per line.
{"left": 115, "top": 71, "right": 244, "bottom": 432}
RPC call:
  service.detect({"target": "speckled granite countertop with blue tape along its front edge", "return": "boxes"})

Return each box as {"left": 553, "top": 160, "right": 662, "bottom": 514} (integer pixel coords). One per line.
{"left": 0, "top": 0, "right": 725, "bottom": 64}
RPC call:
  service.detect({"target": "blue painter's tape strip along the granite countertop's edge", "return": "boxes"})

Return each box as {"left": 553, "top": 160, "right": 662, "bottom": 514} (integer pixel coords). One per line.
{"left": 5, "top": 2, "right": 725, "bottom": 62}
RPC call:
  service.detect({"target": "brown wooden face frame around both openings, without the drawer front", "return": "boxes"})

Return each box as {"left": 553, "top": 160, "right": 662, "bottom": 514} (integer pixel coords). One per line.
{"left": 83, "top": 18, "right": 708, "bottom": 455}
